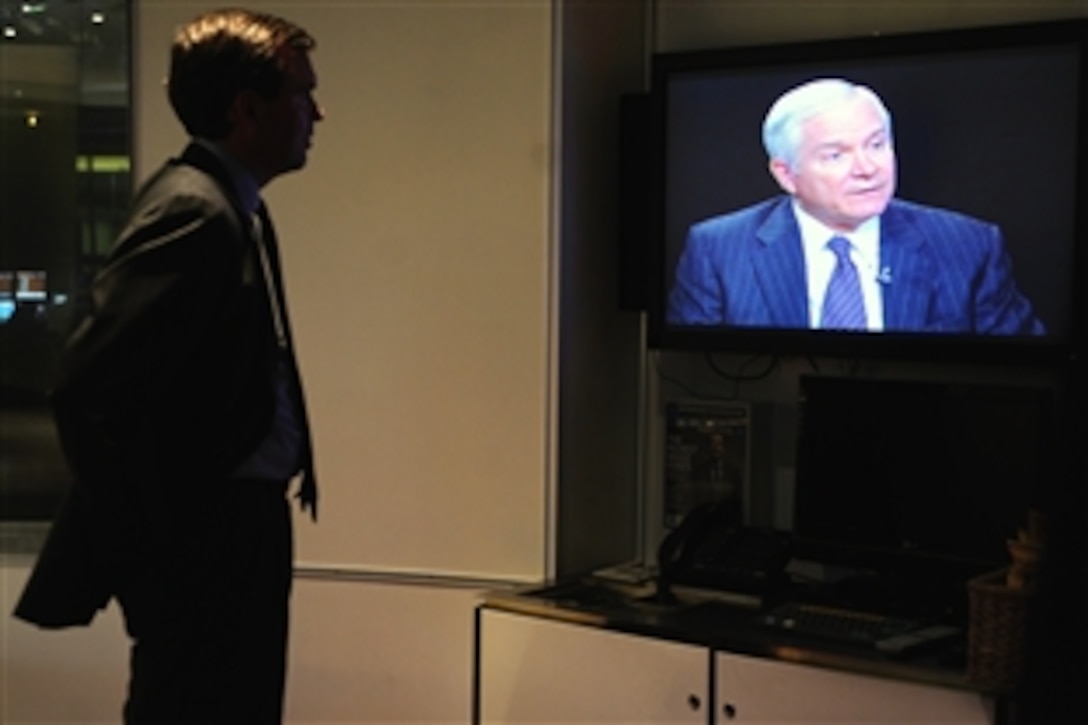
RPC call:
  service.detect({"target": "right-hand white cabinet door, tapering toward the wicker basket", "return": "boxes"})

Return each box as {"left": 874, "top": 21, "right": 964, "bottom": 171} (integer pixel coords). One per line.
{"left": 715, "top": 652, "right": 993, "bottom": 725}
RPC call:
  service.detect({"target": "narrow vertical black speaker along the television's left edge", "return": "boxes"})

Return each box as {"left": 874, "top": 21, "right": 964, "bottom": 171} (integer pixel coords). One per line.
{"left": 616, "top": 94, "right": 660, "bottom": 311}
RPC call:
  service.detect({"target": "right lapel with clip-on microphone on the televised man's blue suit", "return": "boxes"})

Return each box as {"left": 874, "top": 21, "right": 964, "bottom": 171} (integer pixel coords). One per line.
{"left": 880, "top": 201, "right": 936, "bottom": 332}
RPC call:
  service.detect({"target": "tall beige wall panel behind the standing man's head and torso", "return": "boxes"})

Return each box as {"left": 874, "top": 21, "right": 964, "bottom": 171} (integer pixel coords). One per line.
{"left": 134, "top": 0, "right": 555, "bottom": 579}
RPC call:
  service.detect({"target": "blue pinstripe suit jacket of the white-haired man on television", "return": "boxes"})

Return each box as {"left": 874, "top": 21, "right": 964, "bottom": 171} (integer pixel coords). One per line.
{"left": 667, "top": 196, "right": 1043, "bottom": 334}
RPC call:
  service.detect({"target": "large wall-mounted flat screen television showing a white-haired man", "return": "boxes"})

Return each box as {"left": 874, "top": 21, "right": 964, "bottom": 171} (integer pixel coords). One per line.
{"left": 644, "top": 19, "right": 1088, "bottom": 363}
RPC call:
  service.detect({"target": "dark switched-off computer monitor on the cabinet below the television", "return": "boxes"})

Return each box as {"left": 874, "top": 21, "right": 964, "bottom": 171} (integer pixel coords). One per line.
{"left": 793, "top": 376, "right": 1055, "bottom": 572}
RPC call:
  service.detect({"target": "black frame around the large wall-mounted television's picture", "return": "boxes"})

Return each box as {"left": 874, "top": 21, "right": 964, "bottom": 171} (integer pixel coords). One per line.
{"left": 641, "top": 17, "right": 1088, "bottom": 365}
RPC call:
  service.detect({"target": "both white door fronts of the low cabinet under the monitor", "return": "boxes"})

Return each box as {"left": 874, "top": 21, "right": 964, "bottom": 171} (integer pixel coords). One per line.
{"left": 477, "top": 606, "right": 994, "bottom": 725}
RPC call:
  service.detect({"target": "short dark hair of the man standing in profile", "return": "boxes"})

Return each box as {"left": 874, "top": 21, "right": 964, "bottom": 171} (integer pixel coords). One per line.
{"left": 168, "top": 8, "right": 317, "bottom": 139}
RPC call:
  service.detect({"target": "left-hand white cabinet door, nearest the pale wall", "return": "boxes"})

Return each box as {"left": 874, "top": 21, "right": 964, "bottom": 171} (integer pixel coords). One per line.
{"left": 478, "top": 609, "right": 709, "bottom": 725}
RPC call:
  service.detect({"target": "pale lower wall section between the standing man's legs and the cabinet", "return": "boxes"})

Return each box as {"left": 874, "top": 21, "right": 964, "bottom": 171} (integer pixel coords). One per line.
{"left": 285, "top": 578, "right": 481, "bottom": 725}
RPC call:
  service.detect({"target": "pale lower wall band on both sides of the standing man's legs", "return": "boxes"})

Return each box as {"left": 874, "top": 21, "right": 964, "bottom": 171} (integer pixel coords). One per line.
{"left": 0, "top": 555, "right": 481, "bottom": 725}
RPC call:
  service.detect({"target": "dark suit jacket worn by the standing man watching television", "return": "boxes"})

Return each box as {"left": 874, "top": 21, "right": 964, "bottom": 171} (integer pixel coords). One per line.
{"left": 15, "top": 144, "right": 312, "bottom": 627}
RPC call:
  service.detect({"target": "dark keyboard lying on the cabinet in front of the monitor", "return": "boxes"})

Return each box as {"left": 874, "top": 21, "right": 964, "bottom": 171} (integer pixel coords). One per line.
{"left": 759, "top": 602, "right": 962, "bottom": 654}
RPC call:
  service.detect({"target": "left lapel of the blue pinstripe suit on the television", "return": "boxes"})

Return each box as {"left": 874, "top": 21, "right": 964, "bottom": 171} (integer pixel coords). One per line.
{"left": 752, "top": 197, "right": 808, "bottom": 328}
